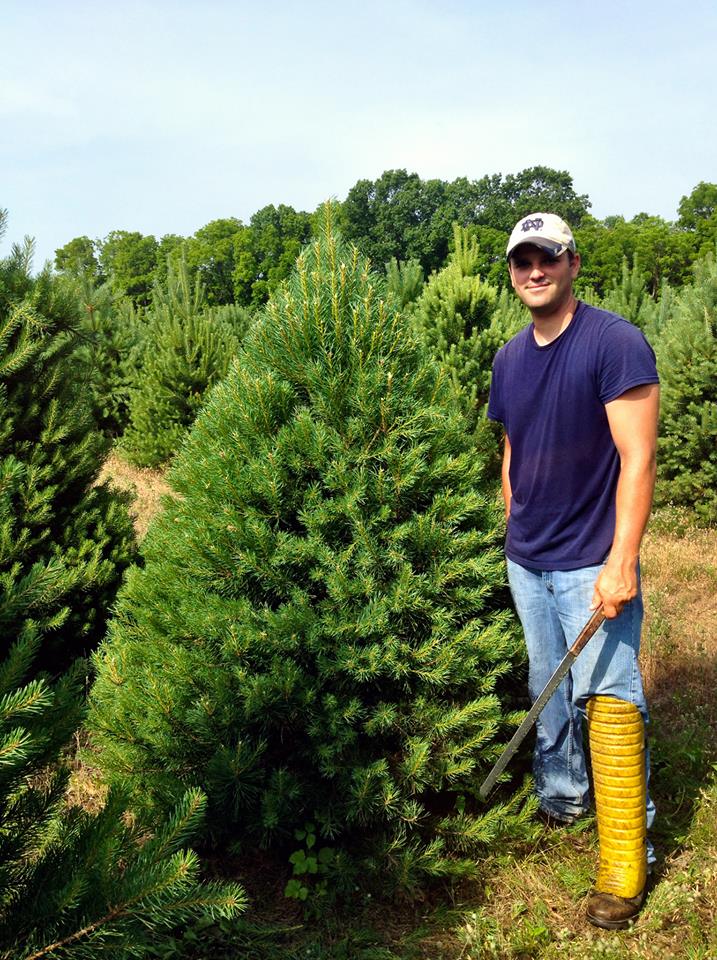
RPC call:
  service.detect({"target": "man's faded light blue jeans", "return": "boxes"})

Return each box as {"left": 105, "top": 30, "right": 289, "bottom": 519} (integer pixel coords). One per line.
{"left": 508, "top": 560, "right": 655, "bottom": 861}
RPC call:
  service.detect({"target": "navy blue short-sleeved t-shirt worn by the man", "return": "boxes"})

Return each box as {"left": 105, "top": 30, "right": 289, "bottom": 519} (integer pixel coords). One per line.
{"left": 488, "top": 303, "right": 658, "bottom": 570}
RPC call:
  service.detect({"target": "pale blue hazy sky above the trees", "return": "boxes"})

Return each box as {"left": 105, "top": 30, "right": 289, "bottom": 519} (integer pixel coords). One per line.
{"left": 0, "top": 0, "right": 717, "bottom": 266}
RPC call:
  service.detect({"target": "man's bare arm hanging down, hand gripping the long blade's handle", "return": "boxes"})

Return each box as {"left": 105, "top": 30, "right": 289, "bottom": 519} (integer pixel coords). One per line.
{"left": 591, "top": 383, "right": 660, "bottom": 620}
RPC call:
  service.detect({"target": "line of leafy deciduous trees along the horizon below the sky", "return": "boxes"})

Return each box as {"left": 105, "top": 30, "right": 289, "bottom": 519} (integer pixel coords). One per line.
{"left": 54, "top": 166, "right": 717, "bottom": 308}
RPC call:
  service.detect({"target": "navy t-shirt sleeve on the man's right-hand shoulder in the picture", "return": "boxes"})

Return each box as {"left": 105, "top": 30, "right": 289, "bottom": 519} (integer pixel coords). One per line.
{"left": 597, "top": 317, "right": 659, "bottom": 404}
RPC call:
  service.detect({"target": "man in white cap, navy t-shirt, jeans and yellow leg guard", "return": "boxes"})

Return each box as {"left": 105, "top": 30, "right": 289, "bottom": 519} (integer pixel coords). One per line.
{"left": 488, "top": 213, "right": 659, "bottom": 929}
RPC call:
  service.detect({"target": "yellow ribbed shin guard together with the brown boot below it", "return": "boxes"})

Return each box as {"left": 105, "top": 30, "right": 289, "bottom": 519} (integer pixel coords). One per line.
{"left": 587, "top": 696, "right": 647, "bottom": 930}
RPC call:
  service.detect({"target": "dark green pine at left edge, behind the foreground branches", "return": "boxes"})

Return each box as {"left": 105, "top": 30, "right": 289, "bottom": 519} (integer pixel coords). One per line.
{"left": 0, "top": 231, "right": 134, "bottom": 670}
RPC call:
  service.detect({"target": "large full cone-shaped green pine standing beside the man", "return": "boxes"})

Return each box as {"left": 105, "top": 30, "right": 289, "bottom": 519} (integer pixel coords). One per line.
{"left": 90, "top": 218, "right": 527, "bottom": 888}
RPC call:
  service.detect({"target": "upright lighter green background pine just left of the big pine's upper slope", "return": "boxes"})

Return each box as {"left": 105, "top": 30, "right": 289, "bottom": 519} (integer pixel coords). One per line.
{"left": 121, "top": 263, "right": 243, "bottom": 467}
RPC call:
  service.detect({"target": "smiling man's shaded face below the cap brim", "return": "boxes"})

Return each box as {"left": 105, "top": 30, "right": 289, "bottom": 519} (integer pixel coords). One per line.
{"left": 509, "top": 243, "right": 580, "bottom": 316}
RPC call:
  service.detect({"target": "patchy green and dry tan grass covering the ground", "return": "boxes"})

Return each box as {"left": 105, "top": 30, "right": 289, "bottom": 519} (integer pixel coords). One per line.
{"left": 96, "top": 458, "right": 717, "bottom": 960}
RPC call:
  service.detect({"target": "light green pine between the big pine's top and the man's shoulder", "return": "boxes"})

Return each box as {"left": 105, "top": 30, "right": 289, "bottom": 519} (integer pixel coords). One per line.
{"left": 414, "top": 225, "right": 527, "bottom": 474}
